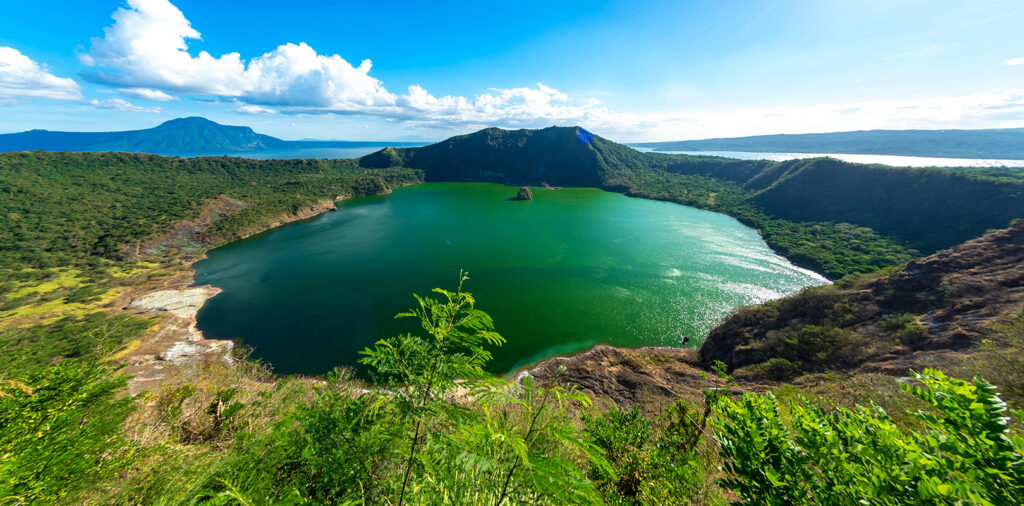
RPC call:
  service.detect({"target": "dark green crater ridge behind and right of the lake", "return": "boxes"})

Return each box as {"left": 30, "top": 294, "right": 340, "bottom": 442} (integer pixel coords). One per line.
{"left": 359, "top": 127, "right": 1024, "bottom": 278}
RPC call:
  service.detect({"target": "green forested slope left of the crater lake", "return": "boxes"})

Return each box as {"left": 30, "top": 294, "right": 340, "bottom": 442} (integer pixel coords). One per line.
{"left": 0, "top": 152, "right": 422, "bottom": 269}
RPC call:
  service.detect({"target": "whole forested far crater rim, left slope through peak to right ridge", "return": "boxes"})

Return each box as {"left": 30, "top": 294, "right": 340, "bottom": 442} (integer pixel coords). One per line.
{"left": 0, "top": 127, "right": 1024, "bottom": 279}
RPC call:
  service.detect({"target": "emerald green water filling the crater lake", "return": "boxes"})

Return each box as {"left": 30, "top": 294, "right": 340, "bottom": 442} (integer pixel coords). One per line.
{"left": 195, "top": 182, "right": 825, "bottom": 374}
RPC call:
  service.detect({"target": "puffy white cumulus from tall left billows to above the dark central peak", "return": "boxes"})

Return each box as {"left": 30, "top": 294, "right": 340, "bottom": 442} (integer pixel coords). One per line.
{"left": 80, "top": 0, "right": 606, "bottom": 124}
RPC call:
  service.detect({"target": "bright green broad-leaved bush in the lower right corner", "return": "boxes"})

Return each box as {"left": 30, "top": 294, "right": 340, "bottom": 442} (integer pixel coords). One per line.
{"left": 715, "top": 370, "right": 1024, "bottom": 505}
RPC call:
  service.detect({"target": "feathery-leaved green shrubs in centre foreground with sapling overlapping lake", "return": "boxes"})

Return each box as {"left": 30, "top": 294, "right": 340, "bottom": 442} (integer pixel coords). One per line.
{"left": 203, "top": 276, "right": 602, "bottom": 505}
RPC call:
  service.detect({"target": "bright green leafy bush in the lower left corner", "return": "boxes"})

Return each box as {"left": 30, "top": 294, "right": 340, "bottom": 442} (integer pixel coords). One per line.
{"left": 0, "top": 361, "right": 131, "bottom": 504}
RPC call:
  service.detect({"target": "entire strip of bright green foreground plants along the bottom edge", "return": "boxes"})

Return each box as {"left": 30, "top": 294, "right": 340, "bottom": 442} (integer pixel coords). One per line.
{"left": 6, "top": 276, "right": 1024, "bottom": 505}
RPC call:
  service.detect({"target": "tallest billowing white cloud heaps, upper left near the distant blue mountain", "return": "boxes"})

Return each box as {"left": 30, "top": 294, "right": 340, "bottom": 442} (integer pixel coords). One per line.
{"left": 81, "top": 0, "right": 395, "bottom": 111}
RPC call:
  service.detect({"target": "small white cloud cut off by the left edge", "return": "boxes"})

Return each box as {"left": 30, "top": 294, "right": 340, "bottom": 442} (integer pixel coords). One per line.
{"left": 0, "top": 46, "right": 82, "bottom": 101}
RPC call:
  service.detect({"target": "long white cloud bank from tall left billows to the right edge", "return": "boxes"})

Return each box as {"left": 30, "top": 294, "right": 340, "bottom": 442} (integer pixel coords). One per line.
{"left": 80, "top": 0, "right": 1024, "bottom": 140}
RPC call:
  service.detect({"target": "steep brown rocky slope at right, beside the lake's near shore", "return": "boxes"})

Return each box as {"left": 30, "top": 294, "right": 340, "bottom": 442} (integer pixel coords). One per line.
{"left": 700, "top": 221, "right": 1024, "bottom": 371}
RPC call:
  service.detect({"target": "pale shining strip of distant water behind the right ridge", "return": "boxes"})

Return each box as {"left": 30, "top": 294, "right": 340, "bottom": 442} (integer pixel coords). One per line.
{"left": 634, "top": 146, "right": 1024, "bottom": 167}
